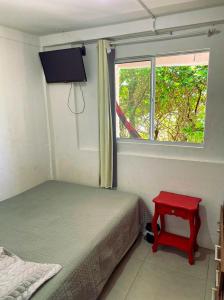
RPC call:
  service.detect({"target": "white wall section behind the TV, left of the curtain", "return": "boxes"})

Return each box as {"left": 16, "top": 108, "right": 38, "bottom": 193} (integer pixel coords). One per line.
{"left": 47, "top": 44, "right": 98, "bottom": 185}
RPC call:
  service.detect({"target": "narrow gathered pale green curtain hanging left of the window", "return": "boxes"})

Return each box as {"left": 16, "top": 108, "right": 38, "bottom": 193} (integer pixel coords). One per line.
{"left": 98, "top": 40, "right": 114, "bottom": 188}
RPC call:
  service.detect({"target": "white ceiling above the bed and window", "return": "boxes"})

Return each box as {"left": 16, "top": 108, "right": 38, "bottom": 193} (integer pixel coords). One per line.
{"left": 0, "top": 0, "right": 224, "bottom": 35}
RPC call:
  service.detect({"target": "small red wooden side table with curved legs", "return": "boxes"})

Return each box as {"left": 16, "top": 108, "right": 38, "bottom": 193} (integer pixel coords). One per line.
{"left": 152, "top": 192, "right": 201, "bottom": 265}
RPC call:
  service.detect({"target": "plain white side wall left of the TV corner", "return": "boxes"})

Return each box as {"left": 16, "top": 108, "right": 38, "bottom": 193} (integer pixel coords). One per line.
{"left": 0, "top": 27, "right": 49, "bottom": 200}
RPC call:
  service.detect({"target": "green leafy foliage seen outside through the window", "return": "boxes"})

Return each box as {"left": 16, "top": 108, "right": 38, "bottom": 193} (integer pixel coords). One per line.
{"left": 119, "top": 66, "right": 208, "bottom": 143}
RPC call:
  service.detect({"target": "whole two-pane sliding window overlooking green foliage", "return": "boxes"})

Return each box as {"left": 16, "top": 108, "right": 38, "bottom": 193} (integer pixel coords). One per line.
{"left": 115, "top": 52, "right": 209, "bottom": 144}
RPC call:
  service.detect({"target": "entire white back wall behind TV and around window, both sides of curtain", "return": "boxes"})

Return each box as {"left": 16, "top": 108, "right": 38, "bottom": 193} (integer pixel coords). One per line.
{"left": 44, "top": 26, "right": 224, "bottom": 248}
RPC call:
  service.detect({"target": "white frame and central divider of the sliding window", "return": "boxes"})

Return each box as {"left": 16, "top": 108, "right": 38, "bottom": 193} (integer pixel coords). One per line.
{"left": 114, "top": 49, "right": 210, "bottom": 148}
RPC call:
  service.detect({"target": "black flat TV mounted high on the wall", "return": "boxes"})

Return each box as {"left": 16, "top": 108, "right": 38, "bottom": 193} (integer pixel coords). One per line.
{"left": 39, "top": 48, "right": 87, "bottom": 83}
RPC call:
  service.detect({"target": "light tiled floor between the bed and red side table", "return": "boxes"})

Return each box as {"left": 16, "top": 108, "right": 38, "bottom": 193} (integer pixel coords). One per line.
{"left": 99, "top": 238, "right": 215, "bottom": 300}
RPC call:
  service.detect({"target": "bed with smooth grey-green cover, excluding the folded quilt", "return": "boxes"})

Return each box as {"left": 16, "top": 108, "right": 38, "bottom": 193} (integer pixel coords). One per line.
{"left": 0, "top": 181, "right": 140, "bottom": 300}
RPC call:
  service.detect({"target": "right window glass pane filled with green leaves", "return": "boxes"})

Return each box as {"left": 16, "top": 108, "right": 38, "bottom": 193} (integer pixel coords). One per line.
{"left": 154, "top": 52, "right": 209, "bottom": 143}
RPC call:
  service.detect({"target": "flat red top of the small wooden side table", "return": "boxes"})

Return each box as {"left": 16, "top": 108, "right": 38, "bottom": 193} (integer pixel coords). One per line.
{"left": 153, "top": 191, "right": 202, "bottom": 210}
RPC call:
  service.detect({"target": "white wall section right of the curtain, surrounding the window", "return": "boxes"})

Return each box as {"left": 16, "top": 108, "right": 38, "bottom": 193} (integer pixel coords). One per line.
{"left": 116, "top": 26, "right": 224, "bottom": 248}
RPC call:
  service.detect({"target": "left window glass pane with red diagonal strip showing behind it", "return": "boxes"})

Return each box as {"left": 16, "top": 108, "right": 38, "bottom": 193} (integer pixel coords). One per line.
{"left": 115, "top": 61, "right": 151, "bottom": 139}
